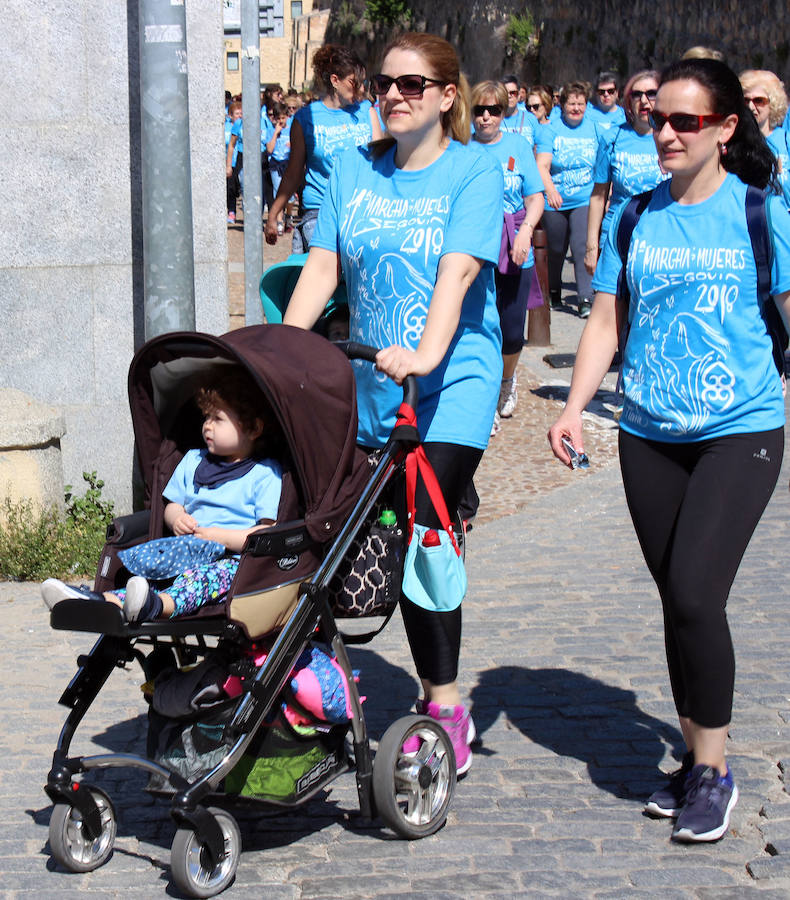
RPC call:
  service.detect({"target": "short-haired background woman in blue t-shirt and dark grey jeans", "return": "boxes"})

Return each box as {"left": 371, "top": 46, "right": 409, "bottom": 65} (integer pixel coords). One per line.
{"left": 535, "top": 81, "right": 598, "bottom": 318}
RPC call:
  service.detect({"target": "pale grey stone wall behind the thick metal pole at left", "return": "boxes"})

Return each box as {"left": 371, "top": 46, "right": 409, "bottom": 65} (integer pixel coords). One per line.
{"left": 0, "top": 0, "right": 228, "bottom": 512}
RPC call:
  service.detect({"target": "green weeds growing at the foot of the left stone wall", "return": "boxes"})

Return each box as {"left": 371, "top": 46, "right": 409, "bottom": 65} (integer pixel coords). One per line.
{"left": 0, "top": 472, "right": 113, "bottom": 581}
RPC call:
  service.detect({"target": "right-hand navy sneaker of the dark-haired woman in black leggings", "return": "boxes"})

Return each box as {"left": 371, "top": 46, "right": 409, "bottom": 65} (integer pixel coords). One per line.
{"left": 672, "top": 765, "right": 738, "bottom": 843}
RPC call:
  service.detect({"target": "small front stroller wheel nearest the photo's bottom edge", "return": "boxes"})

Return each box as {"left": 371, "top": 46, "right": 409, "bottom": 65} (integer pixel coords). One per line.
{"left": 170, "top": 806, "right": 241, "bottom": 897}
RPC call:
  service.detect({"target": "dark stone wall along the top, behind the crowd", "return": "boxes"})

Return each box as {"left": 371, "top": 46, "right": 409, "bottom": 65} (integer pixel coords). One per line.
{"left": 327, "top": 0, "right": 790, "bottom": 85}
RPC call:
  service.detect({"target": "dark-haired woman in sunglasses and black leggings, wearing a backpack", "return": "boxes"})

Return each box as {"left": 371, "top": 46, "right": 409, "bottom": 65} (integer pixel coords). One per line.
{"left": 549, "top": 59, "right": 790, "bottom": 841}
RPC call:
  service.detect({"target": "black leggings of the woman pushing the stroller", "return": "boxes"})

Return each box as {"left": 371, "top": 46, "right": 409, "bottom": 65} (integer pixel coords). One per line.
{"left": 400, "top": 443, "right": 483, "bottom": 684}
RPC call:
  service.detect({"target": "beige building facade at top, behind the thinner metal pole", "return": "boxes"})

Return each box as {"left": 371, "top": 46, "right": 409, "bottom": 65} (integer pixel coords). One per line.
{"left": 223, "top": 0, "right": 329, "bottom": 95}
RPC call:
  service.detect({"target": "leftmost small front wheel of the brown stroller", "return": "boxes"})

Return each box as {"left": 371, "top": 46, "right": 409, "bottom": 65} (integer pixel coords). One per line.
{"left": 49, "top": 787, "right": 117, "bottom": 872}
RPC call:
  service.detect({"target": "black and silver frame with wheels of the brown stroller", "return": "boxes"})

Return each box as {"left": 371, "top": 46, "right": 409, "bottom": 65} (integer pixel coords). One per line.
{"left": 44, "top": 342, "right": 456, "bottom": 897}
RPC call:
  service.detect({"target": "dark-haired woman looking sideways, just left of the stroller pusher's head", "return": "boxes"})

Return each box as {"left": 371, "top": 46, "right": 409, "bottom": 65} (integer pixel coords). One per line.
{"left": 264, "top": 44, "right": 381, "bottom": 253}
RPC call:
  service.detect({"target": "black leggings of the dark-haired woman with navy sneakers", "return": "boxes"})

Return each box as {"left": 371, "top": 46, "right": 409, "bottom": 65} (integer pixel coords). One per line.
{"left": 620, "top": 428, "right": 784, "bottom": 728}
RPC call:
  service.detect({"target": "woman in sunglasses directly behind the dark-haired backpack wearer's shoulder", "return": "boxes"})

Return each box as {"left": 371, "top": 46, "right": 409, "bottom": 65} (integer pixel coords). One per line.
{"left": 584, "top": 69, "right": 667, "bottom": 275}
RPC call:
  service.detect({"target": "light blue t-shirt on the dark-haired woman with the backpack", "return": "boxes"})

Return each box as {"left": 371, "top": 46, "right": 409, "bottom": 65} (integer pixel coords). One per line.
{"left": 593, "top": 174, "right": 790, "bottom": 442}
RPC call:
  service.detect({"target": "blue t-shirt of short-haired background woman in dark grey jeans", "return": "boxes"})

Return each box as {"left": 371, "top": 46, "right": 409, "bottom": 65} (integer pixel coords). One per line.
{"left": 535, "top": 115, "right": 598, "bottom": 209}
